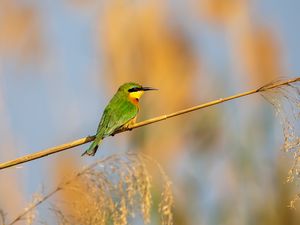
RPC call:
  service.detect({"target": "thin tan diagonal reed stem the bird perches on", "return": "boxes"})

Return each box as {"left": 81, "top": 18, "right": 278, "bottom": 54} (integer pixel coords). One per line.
{"left": 0, "top": 77, "right": 300, "bottom": 170}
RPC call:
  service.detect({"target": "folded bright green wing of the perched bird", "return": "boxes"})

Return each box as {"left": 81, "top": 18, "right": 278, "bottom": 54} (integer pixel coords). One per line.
{"left": 97, "top": 96, "right": 138, "bottom": 138}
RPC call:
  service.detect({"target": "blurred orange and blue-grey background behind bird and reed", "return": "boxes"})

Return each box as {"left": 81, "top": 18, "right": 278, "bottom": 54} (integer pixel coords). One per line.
{"left": 0, "top": 0, "right": 300, "bottom": 225}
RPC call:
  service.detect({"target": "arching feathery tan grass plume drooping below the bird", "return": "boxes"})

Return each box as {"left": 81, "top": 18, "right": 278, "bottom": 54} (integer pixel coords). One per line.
{"left": 10, "top": 153, "right": 173, "bottom": 225}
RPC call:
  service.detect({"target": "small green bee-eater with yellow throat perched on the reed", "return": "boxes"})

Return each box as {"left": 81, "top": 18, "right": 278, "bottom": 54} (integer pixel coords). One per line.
{"left": 82, "top": 82, "right": 157, "bottom": 156}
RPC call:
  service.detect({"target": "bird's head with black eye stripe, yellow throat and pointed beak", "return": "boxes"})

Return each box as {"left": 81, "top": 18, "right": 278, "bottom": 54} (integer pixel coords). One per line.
{"left": 118, "top": 82, "right": 158, "bottom": 104}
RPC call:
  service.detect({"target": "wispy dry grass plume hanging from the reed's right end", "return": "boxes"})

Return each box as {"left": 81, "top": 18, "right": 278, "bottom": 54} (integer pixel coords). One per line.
{"left": 261, "top": 81, "right": 300, "bottom": 207}
